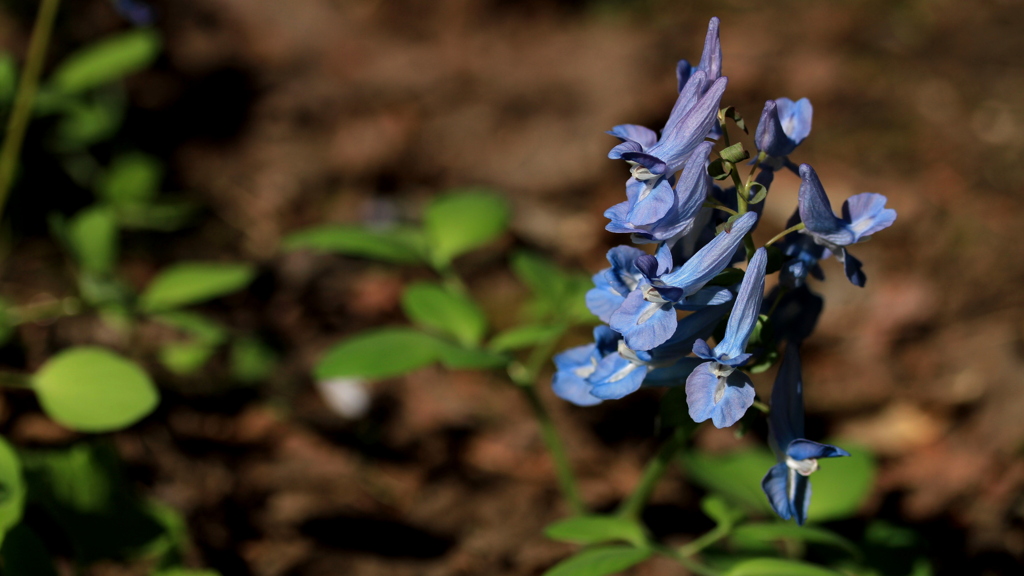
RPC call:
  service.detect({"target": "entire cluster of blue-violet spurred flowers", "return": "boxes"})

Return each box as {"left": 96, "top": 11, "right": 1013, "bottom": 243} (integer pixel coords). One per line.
{"left": 553, "top": 18, "right": 896, "bottom": 524}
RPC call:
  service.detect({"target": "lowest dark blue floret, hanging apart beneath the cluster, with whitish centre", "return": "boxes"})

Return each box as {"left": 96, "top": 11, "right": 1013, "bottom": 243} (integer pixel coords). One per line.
{"left": 761, "top": 343, "right": 850, "bottom": 525}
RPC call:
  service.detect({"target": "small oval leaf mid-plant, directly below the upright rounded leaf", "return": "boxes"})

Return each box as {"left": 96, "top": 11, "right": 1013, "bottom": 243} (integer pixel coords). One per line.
{"left": 401, "top": 282, "right": 487, "bottom": 346}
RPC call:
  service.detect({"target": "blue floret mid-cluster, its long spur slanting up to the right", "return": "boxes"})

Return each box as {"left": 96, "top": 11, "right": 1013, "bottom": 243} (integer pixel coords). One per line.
{"left": 608, "top": 212, "right": 758, "bottom": 351}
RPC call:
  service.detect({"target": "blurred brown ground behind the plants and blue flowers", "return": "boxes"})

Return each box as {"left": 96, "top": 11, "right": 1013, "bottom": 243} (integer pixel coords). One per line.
{"left": 0, "top": 0, "right": 1024, "bottom": 576}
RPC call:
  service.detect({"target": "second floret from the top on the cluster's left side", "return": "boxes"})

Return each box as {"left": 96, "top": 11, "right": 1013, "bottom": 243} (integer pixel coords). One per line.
{"left": 604, "top": 142, "right": 712, "bottom": 243}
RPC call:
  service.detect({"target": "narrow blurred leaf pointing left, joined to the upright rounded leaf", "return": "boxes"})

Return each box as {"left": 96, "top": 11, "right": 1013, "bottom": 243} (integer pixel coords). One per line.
{"left": 282, "top": 224, "right": 425, "bottom": 264}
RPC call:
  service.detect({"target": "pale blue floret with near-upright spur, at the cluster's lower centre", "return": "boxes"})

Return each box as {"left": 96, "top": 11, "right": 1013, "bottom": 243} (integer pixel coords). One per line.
{"left": 686, "top": 248, "right": 768, "bottom": 428}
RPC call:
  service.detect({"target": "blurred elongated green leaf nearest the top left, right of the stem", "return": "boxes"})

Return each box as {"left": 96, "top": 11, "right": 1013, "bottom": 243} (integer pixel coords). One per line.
{"left": 49, "top": 29, "right": 161, "bottom": 94}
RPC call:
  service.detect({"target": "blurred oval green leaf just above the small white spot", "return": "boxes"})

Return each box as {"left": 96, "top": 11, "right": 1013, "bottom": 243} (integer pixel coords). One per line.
{"left": 314, "top": 327, "right": 443, "bottom": 380}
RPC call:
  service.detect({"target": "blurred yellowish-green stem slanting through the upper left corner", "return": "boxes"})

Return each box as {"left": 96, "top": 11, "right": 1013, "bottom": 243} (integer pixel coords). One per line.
{"left": 0, "top": 0, "right": 60, "bottom": 214}
